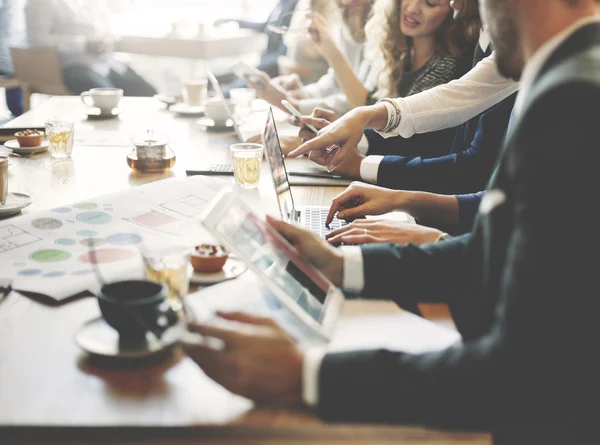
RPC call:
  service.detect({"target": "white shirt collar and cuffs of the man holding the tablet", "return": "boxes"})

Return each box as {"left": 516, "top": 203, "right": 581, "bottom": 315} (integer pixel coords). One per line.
{"left": 303, "top": 17, "right": 600, "bottom": 406}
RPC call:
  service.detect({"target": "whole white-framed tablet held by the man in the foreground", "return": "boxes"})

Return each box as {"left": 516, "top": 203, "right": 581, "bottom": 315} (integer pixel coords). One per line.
{"left": 203, "top": 190, "right": 344, "bottom": 340}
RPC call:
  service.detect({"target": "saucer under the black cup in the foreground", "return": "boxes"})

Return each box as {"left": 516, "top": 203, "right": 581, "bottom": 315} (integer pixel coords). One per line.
{"left": 75, "top": 317, "right": 185, "bottom": 359}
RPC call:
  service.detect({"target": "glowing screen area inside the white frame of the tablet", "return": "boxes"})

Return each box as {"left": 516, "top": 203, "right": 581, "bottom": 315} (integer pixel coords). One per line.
{"left": 216, "top": 202, "right": 330, "bottom": 322}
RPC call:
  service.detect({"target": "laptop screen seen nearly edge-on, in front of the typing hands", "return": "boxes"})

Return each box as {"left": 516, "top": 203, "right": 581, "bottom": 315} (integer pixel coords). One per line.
{"left": 263, "top": 107, "right": 295, "bottom": 222}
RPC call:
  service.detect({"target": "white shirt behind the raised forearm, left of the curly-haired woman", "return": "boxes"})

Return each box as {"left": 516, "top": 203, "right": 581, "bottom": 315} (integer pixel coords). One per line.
{"left": 298, "top": 25, "right": 369, "bottom": 116}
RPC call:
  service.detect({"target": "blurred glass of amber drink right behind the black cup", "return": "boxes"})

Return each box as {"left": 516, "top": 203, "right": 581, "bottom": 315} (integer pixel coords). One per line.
{"left": 142, "top": 247, "right": 190, "bottom": 311}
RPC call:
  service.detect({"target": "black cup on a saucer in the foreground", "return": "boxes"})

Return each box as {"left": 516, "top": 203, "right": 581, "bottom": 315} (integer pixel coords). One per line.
{"left": 97, "top": 280, "right": 177, "bottom": 345}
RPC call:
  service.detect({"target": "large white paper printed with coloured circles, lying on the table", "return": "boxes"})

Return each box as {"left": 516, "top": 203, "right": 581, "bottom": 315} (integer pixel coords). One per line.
{"left": 0, "top": 176, "right": 229, "bottom": 300}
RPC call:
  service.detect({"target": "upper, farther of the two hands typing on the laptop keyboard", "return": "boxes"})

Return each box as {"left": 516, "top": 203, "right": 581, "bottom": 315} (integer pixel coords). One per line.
{"left": 325, "top": 182, "right": 400, "bottom": 225}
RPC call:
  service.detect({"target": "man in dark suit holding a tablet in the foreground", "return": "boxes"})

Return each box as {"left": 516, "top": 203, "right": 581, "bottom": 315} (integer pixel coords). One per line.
{"left": 187, "top": 0, "right": 600, "bottom": 438}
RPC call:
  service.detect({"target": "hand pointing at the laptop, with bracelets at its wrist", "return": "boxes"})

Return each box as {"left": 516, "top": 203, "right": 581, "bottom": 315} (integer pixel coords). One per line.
{"left": 289, "top": 107, "right": 387, "bottom": 171}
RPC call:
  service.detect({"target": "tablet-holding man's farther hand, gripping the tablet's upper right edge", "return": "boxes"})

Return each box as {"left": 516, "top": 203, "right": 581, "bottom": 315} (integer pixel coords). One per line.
{"left": 267, "top": 216, "right": 344, "bottom": 287}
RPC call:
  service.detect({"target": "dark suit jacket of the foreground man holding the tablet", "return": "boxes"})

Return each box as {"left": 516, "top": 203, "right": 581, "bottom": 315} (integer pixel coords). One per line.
{"left": 318, "top": 20, "right": 600, "bottom": 434}
